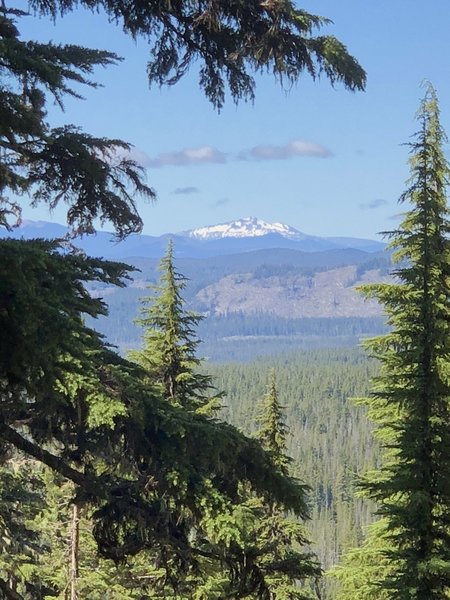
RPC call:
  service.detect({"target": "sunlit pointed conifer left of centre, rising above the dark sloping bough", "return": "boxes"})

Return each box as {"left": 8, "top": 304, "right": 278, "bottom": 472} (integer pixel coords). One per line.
{"left": 131, "top": 240, "right": 220, "bottom": 414}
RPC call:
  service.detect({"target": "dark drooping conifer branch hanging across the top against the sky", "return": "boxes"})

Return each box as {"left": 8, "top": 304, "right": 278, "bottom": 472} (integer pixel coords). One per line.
{"left": 30, "top": 0, "right": 365, "bottom": 108}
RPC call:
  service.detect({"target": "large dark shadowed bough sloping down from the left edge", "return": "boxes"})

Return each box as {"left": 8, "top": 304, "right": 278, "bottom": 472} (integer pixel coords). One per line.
{"left": 0, "top": 240, "right": 316, "bottom": 596}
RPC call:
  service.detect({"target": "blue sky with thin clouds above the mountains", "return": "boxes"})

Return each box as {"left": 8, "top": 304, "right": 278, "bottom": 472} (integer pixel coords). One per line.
{"left": 21, "top": 0, "right": 450, "bottom": 238}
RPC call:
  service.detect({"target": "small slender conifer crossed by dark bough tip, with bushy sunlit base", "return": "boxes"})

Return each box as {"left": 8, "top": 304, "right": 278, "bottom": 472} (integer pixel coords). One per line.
{"left": 199, "top": 372, "right": 321, "bottom": 600}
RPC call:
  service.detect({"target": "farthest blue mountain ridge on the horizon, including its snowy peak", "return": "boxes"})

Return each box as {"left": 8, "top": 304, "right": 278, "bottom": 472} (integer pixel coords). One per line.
{"left": 0, "top": 217, "right": 384, "bottom": 259}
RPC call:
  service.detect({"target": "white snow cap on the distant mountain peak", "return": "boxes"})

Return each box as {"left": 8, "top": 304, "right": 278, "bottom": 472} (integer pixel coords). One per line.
{"left": 187, "top": 217, "right": 304, "bottom": 240}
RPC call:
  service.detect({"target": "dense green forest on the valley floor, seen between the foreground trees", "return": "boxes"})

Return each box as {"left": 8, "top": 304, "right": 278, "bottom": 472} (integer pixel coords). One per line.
{"left": 208, "top": 349, "right": 378, "bottom": 598}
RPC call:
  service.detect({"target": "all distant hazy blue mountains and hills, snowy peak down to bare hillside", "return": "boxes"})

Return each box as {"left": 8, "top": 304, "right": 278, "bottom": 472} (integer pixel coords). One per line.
{"left": 0, "top": 219, "right": 390, "bottom": 360}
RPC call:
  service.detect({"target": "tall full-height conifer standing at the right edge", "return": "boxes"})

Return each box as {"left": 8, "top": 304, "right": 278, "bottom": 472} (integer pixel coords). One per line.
{"left": 356, "top": 85, "right": 450, "bottom": 600}
